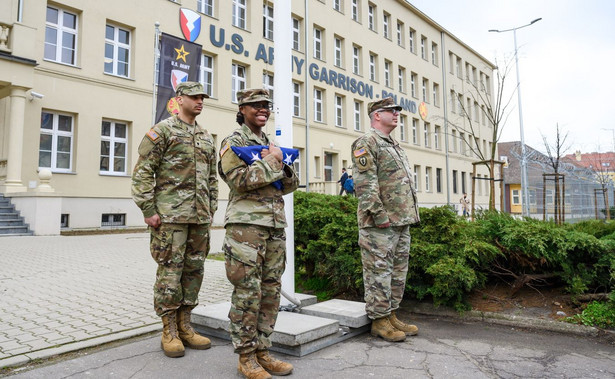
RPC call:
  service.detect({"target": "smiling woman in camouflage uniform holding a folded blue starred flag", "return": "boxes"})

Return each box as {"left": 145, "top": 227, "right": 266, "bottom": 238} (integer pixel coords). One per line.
{"left": 218, "top": 89, "right": 299, "bottom": 378}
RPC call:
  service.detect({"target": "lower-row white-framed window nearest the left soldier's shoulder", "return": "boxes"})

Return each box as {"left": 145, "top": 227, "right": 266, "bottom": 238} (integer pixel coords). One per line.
{"left": 100, "top": 120, "right": 128, "bottom": 175}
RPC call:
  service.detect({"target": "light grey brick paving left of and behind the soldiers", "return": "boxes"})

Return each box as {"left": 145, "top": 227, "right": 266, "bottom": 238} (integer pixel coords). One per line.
{"left": 0, "top": 229, "right": 232, "bottom": 368}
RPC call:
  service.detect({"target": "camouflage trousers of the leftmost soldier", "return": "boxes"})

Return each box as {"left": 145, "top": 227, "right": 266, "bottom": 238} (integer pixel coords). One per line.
{"left": 150, "top": 224, "right": 209, "bottom": 316}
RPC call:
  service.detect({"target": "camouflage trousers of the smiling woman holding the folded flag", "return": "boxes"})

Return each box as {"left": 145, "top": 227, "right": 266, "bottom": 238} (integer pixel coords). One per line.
{"left": 222, "top": 224, "right": 286, "bottom": 354}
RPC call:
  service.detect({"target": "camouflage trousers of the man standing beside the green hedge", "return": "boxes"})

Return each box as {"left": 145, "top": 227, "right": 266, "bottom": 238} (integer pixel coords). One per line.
{"left": 359, "top": 225, "right": 410, "bottom": 320}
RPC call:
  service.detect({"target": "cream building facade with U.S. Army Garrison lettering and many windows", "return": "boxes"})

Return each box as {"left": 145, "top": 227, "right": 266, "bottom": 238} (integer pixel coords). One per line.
{"left": 0, "top": 0, "right": 499, "bottom": 234}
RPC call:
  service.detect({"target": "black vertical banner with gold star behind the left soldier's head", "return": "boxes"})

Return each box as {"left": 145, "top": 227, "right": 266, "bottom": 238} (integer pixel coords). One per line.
{"left": 156, "top": 33, "right": 202, "bottom": 123}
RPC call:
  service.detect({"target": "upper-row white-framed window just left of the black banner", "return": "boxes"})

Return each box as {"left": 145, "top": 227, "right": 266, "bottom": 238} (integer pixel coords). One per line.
{"left": 105, "top": 25, "right": 130, "bottom": 77}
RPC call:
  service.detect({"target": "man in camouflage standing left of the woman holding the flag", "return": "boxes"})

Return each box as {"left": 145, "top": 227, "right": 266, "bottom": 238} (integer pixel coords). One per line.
{"left": 132, "top": 82, "right": 218, "bottom": 357}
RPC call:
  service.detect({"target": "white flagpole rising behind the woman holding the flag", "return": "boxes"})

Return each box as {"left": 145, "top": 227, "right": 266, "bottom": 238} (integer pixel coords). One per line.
{"left": 273, "top": 1, "right": 295, "bottom": 305}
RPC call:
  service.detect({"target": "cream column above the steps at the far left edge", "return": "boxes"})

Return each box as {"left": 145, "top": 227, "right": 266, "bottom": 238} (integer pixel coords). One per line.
{"left": 0, "top": 87, "right": 27, "bottom": 193}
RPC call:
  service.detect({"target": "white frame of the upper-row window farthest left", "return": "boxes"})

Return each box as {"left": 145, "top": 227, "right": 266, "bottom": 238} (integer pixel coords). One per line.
{"left": 44, "top": 6, "right": 79, "bottom": 66}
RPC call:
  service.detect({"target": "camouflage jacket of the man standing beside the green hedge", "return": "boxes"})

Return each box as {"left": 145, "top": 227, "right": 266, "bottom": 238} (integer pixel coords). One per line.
{"left": 352, "top": 128, "right": 420, "bottom": 228}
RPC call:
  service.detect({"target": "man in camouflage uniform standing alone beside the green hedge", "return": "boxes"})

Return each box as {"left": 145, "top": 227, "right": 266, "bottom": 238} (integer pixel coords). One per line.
{"left": 352, "top": 97, "right": 419, "bottom": 341}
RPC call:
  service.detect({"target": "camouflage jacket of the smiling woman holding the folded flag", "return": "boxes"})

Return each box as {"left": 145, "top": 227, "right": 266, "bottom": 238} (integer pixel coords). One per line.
{"left": 218, "top": 124, "right": 299, "bottom": 228}
